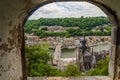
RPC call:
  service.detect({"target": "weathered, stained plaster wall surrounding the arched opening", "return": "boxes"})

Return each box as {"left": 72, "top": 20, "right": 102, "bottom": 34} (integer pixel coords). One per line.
{"left": 0, "top": 0, "right": 120, "bottom": 80}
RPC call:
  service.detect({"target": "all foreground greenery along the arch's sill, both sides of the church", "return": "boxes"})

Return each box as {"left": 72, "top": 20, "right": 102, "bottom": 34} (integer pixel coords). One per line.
{"left": 25, "top": 43, "right": 109, "bottom": 77}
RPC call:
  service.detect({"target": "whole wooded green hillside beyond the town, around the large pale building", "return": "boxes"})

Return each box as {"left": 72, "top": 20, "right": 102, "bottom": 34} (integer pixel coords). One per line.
{"left": 24, "top": 17, "right": 111, "bottom": 38}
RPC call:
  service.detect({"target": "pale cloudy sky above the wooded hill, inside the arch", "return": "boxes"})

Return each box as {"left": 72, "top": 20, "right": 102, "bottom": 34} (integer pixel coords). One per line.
{"left": 29, "top": 2, "right": 106, "bottom": 19}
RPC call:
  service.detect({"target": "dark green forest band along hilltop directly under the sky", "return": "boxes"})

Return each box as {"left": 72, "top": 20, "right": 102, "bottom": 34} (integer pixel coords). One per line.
{"left": 24, "top": 17, "right": 110, "bottom": 33}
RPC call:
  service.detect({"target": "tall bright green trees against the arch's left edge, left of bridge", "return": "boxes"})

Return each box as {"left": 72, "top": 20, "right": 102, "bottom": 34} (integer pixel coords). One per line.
{"left": 25, "top": 43, "right": 56, "bottom": 76}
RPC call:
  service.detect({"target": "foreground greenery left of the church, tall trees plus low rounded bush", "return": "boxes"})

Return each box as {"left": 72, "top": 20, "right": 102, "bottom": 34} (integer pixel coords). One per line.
{"left": 25, "top": 43, "right": 79, "bottom": 77}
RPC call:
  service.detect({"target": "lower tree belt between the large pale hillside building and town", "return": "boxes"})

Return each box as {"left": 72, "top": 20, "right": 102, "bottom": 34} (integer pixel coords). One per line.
{"left": 33, "top": 25, "right": 112, "bottom": 38}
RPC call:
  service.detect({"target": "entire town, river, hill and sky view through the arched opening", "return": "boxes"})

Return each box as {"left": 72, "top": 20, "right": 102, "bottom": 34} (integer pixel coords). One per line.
{"left": 24, "top": 2, "right": 112, "bottom": 76}
